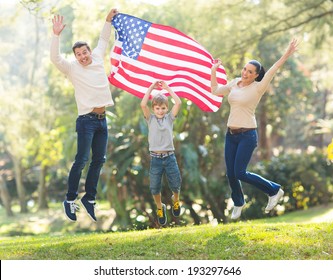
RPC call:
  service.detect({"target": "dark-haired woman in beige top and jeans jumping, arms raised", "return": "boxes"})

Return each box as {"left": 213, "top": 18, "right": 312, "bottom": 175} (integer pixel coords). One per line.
{"left": 211, "top": 39, "right": 298, "bottom": 219}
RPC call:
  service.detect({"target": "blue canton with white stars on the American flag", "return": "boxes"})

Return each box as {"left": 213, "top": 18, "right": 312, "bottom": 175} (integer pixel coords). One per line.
{"left": 112, "top": 14, "right": 152, "bottom": 60}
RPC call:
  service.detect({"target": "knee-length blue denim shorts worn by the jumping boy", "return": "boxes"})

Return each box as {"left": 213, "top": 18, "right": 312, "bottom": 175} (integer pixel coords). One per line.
{"left": 149, "top": 154, "right": 182, "bottom": 195}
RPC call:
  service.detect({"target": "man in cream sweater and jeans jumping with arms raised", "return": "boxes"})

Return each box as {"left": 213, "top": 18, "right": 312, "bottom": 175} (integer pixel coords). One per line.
{"left": 50, "top": 9, "right": 118, "bottom": 222}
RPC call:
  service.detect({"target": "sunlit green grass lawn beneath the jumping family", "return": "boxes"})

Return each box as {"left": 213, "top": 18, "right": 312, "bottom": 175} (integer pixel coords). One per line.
{"left": 0, "top": 202, "right": 333, "bottom": 260}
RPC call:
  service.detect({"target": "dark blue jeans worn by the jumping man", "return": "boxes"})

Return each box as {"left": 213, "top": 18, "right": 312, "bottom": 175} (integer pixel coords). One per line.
{"left": 66, "top": 115, "right": 108, "bottom": 200}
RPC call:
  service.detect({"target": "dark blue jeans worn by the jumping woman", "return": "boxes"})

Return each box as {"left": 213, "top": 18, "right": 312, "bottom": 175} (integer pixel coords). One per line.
{"left": 224, "top": 129, "right": 281, "bottom": 206}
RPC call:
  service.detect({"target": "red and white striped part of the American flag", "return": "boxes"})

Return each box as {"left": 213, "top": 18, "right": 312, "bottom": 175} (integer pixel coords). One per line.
{"left": 108, "top": 13, "right": 227, "bottom": 112}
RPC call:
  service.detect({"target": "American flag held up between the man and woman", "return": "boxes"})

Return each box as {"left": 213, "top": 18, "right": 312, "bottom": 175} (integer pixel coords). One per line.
{"left": 109, "top": 13, "right": 227, "bottom": 112}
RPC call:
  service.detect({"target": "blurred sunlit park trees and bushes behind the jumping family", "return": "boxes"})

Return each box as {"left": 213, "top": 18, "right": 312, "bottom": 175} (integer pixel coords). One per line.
{"left": 0, "top": 0, "right": 333, "bottom": 258}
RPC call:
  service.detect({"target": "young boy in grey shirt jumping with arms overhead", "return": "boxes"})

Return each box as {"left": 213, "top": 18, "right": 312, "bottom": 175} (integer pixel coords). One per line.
{"left": 141, "top": 81, "right": 181, "bottom": 225}
